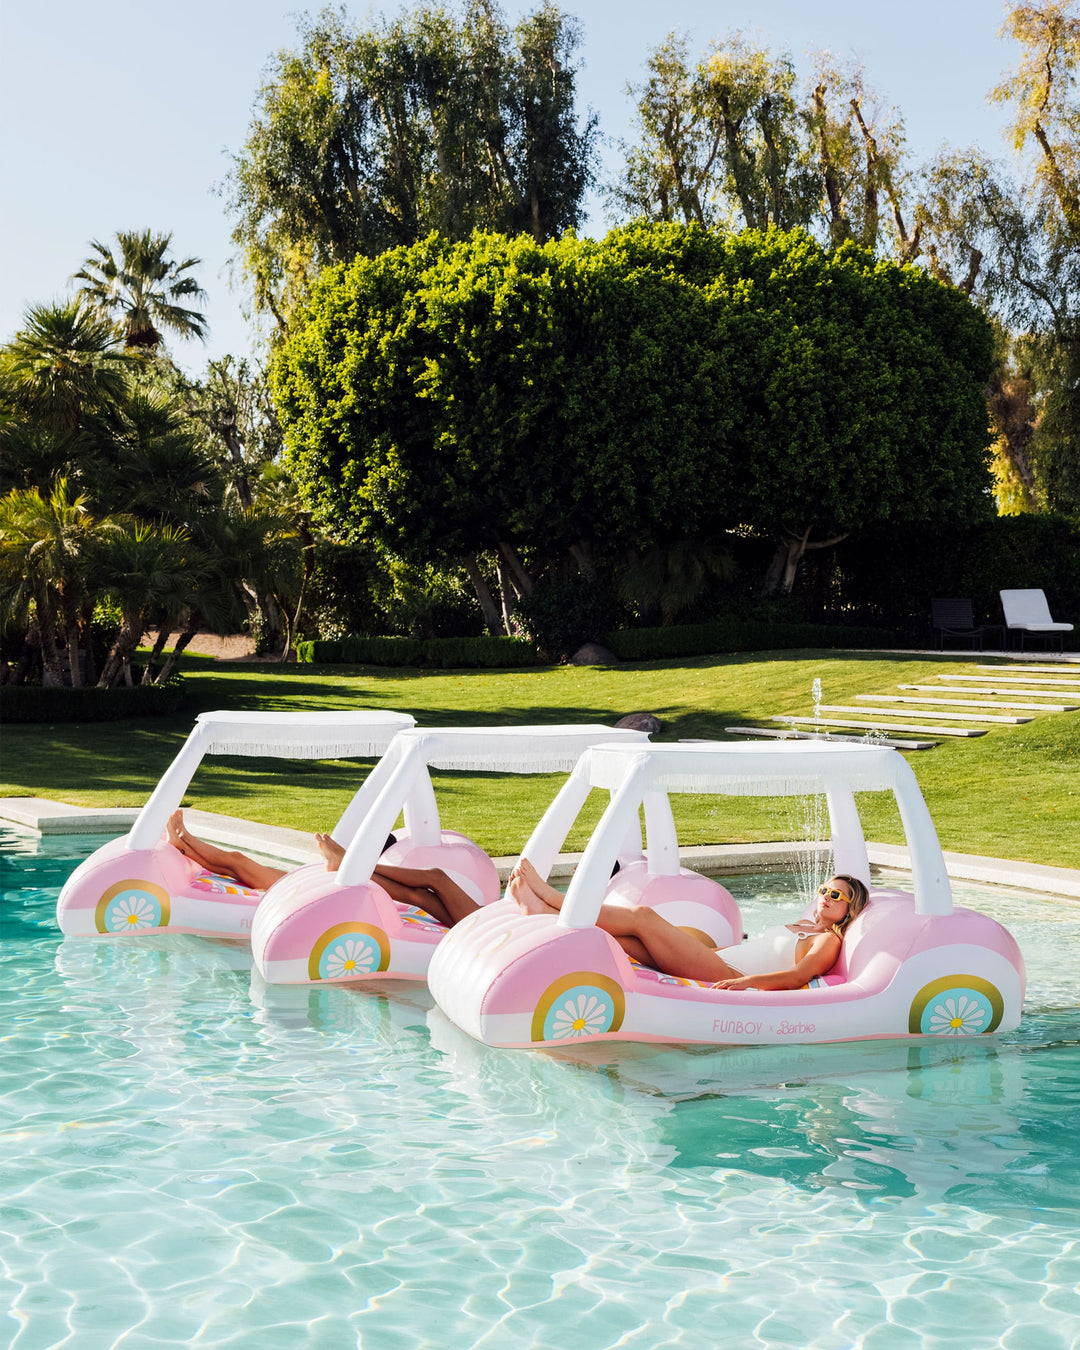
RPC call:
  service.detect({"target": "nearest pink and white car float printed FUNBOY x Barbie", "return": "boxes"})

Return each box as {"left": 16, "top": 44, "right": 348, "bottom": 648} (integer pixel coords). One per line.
{"left": 428, "top": 741, "right": 1025, "bottom": 1048}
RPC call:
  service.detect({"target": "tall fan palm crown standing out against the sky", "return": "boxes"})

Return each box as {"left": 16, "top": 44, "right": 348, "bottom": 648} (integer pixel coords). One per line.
{"left": 73, "top": 230, "right": 208, "bottom": 351}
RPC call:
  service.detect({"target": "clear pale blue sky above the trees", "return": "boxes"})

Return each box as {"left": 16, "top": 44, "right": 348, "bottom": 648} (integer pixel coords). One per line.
{"left": 0, "top": 0, "right": 1015, "bottom": 370}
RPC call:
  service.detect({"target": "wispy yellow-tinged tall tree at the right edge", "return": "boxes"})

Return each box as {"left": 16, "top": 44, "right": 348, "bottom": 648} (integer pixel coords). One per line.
{"left": 923, "top": 0, "right": 1080, "bottom": 512}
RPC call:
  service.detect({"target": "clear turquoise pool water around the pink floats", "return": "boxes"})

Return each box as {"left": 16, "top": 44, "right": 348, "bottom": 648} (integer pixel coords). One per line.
{"left": 0, "top": 833, "right": 1080, "bottom": 1350}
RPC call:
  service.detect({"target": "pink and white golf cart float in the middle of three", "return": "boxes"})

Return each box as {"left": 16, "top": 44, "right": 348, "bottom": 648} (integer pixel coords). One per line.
{"left": 251, "top": 726, "right": 702, "bottom": 984}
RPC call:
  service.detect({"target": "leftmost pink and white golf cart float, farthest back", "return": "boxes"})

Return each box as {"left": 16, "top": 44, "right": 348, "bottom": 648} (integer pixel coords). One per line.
{"left": 57, "top": 710, "right": 416, "bottom": 938}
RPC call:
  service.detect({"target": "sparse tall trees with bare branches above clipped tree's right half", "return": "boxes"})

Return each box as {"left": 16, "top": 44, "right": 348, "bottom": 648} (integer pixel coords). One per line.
{"left": 609, "top": 34, "right": 919, "bottom": 262}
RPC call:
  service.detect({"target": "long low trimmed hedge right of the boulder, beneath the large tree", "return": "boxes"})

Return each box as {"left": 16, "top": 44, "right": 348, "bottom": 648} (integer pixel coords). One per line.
{"left": 601, "top": 618, "right": 895, "bottom": 662}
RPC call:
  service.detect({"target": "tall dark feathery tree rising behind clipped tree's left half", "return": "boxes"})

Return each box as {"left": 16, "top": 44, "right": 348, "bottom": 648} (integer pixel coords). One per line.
{"left": 228, "top": 0, "right": 597, "bottom": 324}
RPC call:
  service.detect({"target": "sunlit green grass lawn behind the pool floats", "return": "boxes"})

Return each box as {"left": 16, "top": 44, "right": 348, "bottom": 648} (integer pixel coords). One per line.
{"left": 0, "top": 651, "right": 1080, "bottom": 867}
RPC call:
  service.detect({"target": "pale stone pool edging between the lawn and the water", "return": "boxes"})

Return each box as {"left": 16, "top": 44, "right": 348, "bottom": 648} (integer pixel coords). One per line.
{"left": 0, "top": 797, "right": 1080, "bottom": 900}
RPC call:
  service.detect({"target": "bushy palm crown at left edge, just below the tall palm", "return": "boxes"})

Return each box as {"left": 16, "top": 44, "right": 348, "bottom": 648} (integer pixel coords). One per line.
{"left": 0, "top": 298, "right": 131, "bottom": 435}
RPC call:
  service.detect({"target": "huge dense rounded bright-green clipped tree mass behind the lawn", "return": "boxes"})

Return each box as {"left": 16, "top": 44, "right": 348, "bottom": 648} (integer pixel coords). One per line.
{"left": 271, "top": 224, "right": 991, "bottom": 617}
